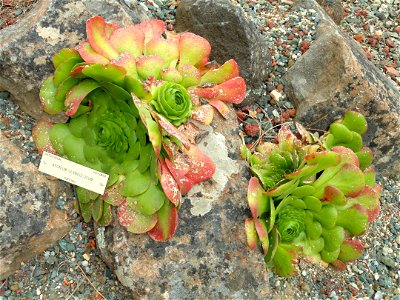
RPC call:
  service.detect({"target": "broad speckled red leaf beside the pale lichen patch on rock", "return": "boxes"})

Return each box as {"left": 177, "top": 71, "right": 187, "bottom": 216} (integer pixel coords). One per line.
{"left": 182, "top": 145, "right": 216, "bottom": 184}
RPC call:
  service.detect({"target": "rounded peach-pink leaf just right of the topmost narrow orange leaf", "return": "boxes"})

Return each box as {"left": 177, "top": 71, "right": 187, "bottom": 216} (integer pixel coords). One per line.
{"left": 110, "top": 26, "right": 144, "bottom": 57}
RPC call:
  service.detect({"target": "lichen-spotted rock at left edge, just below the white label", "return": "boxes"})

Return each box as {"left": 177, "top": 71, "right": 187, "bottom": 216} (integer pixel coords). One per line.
{"left": 0, "top": 134, "right": 71, "bottom": 280}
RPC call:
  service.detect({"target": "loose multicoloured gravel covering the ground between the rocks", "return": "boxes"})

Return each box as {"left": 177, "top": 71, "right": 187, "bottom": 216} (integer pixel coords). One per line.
{"left": 0, "top": 0, "right": 400, "bottom": 300}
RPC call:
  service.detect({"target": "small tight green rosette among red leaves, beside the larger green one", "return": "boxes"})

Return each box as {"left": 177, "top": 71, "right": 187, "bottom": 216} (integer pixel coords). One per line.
{"left": 150, "top": 82, "right": 192, "bottom": 126}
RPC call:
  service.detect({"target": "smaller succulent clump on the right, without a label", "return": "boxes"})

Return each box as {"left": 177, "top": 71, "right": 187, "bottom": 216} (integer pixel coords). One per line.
{"left": 242, "top": 112, "right": 381, "bottom": 276}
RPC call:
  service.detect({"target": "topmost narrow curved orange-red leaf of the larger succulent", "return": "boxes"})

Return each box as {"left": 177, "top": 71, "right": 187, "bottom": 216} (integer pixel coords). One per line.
{"left": 86, "top": 16, "right": 118, "bottom": 59}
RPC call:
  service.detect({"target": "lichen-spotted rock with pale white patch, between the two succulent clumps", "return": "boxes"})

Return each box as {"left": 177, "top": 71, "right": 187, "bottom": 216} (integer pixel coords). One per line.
{"left": 96, "top": 111, "right": 269, "bottom": 299}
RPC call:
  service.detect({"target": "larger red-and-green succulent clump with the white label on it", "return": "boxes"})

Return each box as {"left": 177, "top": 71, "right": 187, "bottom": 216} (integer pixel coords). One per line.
{"left": 34, "top": 16, "right": 246, "bottom": 241}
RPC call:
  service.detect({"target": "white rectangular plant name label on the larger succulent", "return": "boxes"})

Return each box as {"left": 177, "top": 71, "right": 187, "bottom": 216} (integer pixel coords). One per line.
{"left": 39, "top": 152, "right": 108, "bottom": 195}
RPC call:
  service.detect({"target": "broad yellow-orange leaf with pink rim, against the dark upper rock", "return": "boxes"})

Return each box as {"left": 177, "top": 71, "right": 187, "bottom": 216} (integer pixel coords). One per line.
{"left": 179, "top": 32, "right": 211, "bottom": 65}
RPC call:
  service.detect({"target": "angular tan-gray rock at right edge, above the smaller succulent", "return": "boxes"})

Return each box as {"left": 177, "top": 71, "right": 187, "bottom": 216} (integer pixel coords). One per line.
{"left": 285, "top": 0, "right": 400, "bottom": 175}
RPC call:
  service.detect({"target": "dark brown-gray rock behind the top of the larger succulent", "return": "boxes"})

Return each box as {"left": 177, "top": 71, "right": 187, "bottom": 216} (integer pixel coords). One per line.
{"left": 175, "top": 0, "right": 272, "bottom": 105}
